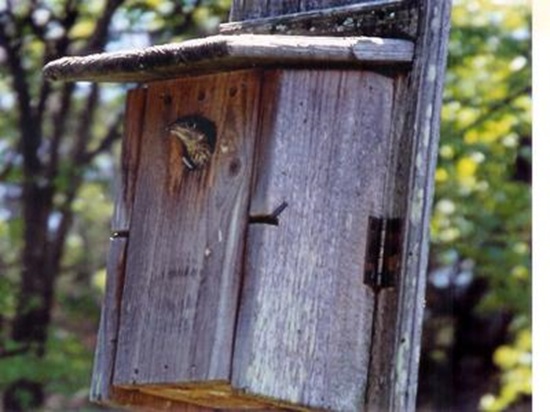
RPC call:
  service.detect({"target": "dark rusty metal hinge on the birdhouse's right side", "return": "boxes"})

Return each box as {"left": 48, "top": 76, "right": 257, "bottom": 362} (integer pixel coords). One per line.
{"left": 364, "top": 216, "right": 402, "bottom": 291}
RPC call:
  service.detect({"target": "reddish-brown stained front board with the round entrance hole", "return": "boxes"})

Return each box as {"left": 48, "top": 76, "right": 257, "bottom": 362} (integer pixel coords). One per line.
{"left": 114, "top": 71, "right": 261, "bottom": 385}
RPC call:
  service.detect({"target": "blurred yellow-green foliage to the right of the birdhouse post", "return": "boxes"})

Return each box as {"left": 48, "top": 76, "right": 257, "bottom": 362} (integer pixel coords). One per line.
{"left": 431, "top": 0, "right": 531, "bottom": 411}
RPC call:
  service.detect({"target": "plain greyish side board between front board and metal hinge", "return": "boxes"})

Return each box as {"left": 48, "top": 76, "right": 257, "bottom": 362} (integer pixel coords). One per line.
{"left": 233, "top": 71, "right": 393, "bottom": 411}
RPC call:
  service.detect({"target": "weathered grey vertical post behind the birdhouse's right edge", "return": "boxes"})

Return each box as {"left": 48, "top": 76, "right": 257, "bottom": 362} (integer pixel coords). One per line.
{"left": 367, "top": 0, "right": 451, "bottom": 411}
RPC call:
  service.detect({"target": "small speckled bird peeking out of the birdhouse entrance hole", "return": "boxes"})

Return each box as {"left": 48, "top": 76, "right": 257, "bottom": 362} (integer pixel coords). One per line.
{"left": 168, "top": 115, "right": 216, "bottom": 170}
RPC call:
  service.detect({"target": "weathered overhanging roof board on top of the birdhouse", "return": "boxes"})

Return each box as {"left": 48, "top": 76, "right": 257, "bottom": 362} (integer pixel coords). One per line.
{"left": 43, "top": 34, "right": 414, "bottom": 82}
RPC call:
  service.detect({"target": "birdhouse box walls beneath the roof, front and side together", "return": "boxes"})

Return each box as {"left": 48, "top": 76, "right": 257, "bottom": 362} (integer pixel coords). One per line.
{"left": 100, "top": 70, "right": 402, "bottom": 410}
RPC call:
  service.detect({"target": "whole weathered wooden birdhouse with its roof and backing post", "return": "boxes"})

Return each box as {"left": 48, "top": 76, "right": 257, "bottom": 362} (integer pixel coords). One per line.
{"left": 45, "top": 0, "right": 450, "bottom": 411}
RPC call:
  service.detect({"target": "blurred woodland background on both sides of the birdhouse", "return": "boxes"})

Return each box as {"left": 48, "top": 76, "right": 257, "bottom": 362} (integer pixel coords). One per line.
{"left": 0, "top": 0, "right": 531, "bottom": 411}
